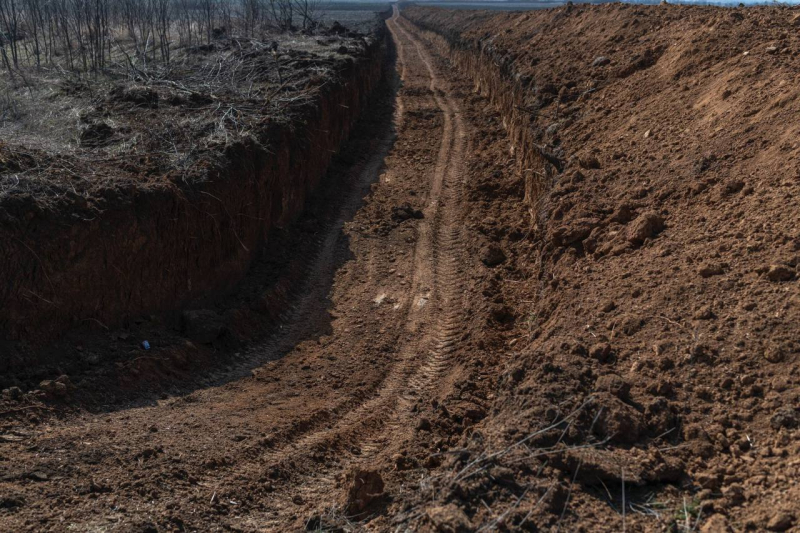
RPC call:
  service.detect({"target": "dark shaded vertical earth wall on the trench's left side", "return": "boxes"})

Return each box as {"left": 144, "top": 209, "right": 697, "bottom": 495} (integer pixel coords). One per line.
{"left": 0, "top": 30, "right": 388, "bottom": 348}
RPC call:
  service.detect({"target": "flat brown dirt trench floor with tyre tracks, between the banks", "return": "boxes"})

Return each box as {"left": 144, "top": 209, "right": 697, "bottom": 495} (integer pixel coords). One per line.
{"left": 0, "top": 12, "right": 470, "bottom": 531}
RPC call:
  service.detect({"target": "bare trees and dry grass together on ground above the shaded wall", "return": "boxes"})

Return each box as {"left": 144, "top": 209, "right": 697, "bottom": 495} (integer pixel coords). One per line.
{"left": 0, "top": 0, "right": 382, "bottom": 201}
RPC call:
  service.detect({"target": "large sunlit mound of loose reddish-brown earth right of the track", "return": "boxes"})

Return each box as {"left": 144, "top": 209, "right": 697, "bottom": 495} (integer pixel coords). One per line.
{"left": 404, "top": 5, "right": 800, "bottom": 531}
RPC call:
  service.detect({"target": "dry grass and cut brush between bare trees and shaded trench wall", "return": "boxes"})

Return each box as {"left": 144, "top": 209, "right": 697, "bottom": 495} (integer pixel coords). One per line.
{"left": 0, "top": 30, "right": 363, "bottom": 203}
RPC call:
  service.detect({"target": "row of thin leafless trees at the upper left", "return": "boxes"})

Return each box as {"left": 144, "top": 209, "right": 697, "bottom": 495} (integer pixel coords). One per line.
{"left": 0, "top": 0, "right": 318, "bottom": 75}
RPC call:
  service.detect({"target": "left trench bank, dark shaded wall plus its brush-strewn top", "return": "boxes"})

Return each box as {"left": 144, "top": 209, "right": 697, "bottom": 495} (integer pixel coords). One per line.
{"left": 0, "top": 22, "right": 386, "bottom": 348}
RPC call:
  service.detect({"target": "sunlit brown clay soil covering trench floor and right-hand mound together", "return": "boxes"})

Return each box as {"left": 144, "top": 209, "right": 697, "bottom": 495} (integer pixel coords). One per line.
{"left": 0, "top": 4, "right": 800, "bottom": 532}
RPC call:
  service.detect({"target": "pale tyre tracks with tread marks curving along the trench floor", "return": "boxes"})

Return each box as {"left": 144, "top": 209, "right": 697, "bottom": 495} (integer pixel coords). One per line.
{"left": 241, "top": 8, "right": 467, "bottom": 526}
